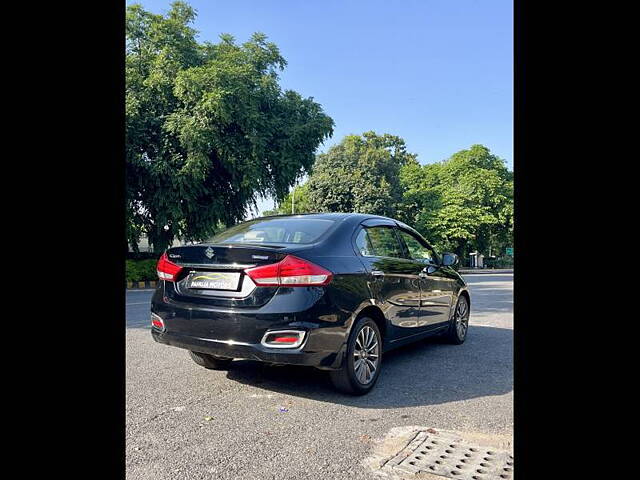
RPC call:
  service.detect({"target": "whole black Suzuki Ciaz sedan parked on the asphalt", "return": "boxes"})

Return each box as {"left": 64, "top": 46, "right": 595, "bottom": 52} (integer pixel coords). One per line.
{"left": 151, "top": 213, "right": 470, "bottom": 395}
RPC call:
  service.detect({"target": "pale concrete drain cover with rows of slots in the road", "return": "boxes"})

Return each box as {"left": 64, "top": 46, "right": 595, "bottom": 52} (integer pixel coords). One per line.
{"left": 385, "top": 430, "right": 513, "bottom": 480}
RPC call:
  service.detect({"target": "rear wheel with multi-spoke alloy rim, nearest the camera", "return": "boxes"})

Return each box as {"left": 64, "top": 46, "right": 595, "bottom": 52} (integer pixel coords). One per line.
{"left": 329, "top": 317, "right": 382, "bottom": 395}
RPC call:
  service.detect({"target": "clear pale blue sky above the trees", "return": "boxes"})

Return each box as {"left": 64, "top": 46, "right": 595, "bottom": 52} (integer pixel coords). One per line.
{"left": 127, "top": 0, "right": 513, "bottom": 212}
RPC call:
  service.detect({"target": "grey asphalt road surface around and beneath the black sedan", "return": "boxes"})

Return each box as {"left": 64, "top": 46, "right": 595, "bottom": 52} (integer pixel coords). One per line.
{"left": 126, "top": 274, "right": 513, "bottom": 480}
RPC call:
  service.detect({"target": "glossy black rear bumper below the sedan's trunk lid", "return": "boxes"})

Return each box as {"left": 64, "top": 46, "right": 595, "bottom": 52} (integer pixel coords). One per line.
{"left": 151, "top": 280, "right": 352, "bottom": 369}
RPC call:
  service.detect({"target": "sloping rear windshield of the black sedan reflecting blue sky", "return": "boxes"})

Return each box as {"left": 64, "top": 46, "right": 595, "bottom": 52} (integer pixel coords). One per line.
{"left": 210, "top": 218, "right": 334, "bottom": 244}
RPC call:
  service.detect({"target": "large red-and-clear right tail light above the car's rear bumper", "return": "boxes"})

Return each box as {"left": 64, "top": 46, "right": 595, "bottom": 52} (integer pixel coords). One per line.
{"left": 244, "top": 255, "right": 333, "bottom": 287}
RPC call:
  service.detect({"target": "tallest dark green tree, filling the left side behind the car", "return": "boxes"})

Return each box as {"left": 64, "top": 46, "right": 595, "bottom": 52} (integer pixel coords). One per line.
{"left": 126, "top": 2, "right": 333, "bottom": 251}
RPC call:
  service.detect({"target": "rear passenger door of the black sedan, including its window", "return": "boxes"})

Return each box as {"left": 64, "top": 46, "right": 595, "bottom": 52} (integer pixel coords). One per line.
{"left": 355, "top": 219, "right": 422, "bottom": 339}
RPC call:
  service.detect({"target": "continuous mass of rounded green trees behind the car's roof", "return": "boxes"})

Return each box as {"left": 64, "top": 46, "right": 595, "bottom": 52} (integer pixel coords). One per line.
{"left": 264, "top": 137, "right": 513, "bottom": 264}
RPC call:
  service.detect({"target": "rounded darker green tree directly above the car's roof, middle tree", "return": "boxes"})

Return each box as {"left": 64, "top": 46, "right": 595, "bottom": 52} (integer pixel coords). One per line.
{"left": 306, "top": 132, "right": 416, "bottom": 215}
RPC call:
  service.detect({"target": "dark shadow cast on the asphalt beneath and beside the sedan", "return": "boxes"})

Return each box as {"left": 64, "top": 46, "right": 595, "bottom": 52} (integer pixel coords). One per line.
{"left": 222, "top": 325, "right": 513, "bottom": 409}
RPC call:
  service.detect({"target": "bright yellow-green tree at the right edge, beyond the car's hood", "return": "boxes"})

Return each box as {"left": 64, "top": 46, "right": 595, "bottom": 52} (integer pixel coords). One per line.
{"left": 400, "top": 145, "right": 513, "bottom": 257}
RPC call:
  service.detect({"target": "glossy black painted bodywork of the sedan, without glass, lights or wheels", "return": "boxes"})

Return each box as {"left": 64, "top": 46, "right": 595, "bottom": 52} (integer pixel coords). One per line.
{"left": 151, "top": 213, "right": 468, "bottom": 369}
